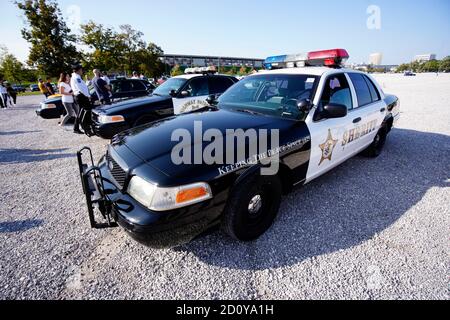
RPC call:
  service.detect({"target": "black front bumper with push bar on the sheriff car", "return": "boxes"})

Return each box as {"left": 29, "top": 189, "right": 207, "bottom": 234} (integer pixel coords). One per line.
{"left": 78, "top": 148, "right": 225, "bottom": 248}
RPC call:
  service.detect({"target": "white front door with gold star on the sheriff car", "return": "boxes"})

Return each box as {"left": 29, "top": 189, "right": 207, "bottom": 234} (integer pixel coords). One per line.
{"left": 306, "top": 73, "right": 357, "bottom": 182}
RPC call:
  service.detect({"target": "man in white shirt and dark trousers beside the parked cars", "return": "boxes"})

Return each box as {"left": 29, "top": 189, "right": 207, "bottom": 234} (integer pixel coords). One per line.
{"left": 70, "top": 65, "right": 92, "bottom": 134}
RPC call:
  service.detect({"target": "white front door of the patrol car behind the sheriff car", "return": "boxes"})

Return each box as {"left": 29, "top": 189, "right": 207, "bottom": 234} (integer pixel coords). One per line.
{"left": 173, "top": 76, "right": 209, "bottom": 115}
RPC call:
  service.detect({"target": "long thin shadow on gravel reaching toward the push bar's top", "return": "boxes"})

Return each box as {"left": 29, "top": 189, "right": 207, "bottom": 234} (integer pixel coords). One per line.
{"left": 0, "top": 148, "right": 75, "bottom": 164}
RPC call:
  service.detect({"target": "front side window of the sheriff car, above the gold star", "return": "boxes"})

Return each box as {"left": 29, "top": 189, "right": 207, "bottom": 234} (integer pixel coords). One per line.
{"left": 319, "top": 73, "right": 353, "bottom": 110}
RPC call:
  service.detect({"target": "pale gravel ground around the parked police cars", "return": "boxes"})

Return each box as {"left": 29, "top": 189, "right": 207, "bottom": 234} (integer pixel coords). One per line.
{"left": 0, "top": 75, "right": 450, "bottom": 299}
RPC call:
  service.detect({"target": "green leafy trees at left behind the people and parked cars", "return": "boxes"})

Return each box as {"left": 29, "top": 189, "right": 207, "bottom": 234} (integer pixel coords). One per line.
{"left": 0, "top": 0, "right": 167, "bottom": 82}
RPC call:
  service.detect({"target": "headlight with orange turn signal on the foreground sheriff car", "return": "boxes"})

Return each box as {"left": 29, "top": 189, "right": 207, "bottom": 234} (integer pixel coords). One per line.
{"left": 128, "top": 176, "right": 212, "bottom": 211}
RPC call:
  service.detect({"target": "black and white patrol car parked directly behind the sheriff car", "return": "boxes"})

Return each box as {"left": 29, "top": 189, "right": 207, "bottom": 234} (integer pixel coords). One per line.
{"left": 92, "top": 72, "right": 238, "bottom": 139}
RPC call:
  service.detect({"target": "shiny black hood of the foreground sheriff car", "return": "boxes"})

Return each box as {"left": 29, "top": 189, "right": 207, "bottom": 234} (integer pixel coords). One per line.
{"left": 112, "top": 109, "right": 303, "bottom": 180}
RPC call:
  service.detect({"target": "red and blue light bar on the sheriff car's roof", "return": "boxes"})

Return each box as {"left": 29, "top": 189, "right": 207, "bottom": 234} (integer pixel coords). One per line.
{"left": 264, "top": 49, "right": 349, "bottom": 70}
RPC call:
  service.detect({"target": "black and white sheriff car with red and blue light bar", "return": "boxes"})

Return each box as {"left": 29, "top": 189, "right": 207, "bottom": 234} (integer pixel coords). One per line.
{"left": 78, "top": 49, "right": 399, "bottom": 247}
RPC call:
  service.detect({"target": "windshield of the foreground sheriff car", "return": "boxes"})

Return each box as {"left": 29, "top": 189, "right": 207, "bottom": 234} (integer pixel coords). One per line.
{"left": 219, "top": 74, "right": 318, "bottom": 120}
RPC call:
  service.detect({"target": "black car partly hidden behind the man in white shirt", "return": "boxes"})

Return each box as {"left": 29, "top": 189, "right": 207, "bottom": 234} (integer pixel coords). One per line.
{"left": 36, "top": 78, "right": 154, "bottom": 119}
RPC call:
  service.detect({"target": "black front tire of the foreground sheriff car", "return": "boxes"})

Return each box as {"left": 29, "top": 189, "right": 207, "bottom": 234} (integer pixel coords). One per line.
{"left": 222, "top": 176, "right": 282, "bottom": 242}
